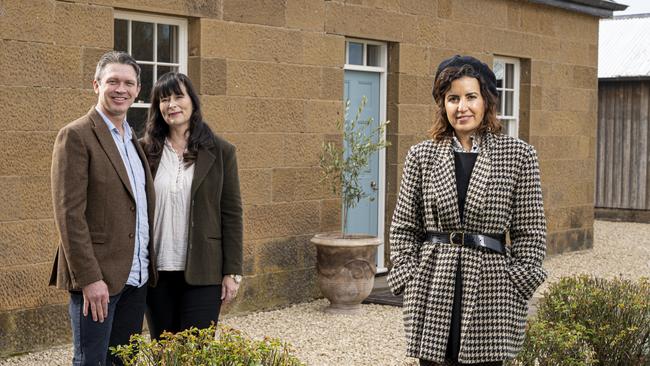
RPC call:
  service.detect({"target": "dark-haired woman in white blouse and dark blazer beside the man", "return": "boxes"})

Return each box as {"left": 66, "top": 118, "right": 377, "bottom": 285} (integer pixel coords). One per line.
{"left": 142, "top": 72, "right": 243, "bottom": 339}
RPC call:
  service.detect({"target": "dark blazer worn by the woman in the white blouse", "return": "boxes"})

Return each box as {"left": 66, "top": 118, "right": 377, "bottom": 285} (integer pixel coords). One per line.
{"left": 152, "top": 136, "right": 243, "bottom": 285}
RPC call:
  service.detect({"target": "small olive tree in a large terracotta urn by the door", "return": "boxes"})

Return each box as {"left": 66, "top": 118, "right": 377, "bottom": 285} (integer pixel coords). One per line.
{"left": 311, "top": 97, "right": 389, "bottom": 313}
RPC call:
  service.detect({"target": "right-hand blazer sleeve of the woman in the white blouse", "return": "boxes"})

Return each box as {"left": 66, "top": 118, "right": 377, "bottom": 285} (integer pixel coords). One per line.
{"left": 221, "top": 144, "right": 244, "bottom": 275}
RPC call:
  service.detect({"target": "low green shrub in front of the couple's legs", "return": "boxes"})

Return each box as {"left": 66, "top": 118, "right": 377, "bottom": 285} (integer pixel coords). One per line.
{"left": 111, "top": 325, "right": 303, "bottom": 366}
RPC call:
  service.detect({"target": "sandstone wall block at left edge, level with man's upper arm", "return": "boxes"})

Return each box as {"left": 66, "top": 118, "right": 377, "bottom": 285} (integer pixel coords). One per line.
{"left": 0, "top": 132, "right": 56, "bottom": 176}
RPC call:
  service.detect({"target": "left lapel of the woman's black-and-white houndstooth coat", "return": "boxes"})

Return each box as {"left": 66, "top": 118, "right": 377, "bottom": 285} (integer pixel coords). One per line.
{"left": 431, "top": 139, "right": 461, "bottom": 231}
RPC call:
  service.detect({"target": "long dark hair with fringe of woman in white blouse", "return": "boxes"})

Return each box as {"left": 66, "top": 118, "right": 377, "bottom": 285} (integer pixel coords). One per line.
{"left": 143, "top": 72, "right": 214, "bottom": 171}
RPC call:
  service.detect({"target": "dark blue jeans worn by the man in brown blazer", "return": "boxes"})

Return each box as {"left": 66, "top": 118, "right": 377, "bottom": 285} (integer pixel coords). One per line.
{"left": 68, "top": 285, "right": 147, "bottom": 366}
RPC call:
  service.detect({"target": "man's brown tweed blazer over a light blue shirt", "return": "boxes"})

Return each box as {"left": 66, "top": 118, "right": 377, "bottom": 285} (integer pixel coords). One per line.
{"left": 50, "top": 107, "right": 157, "bottom": 295}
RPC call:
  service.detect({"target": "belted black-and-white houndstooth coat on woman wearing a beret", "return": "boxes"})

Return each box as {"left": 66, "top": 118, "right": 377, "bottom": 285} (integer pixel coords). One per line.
{"left": 388, "top": 134, "right": 546, "bottom": 363}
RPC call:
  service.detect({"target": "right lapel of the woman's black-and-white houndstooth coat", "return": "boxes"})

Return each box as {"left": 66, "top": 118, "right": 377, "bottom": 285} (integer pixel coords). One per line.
{"left": 465, "top": 134, "right": 492, "bottom": 232}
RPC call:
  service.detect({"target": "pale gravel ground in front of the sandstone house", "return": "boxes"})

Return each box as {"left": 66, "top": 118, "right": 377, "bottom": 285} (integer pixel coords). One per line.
{"left": 0, "top": 221, "right": 650, "bottom": 366}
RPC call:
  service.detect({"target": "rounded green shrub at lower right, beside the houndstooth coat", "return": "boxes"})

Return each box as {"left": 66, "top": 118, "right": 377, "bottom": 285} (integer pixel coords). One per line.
{"left": 517, "top": 276, "right": 650, "bottom": 366}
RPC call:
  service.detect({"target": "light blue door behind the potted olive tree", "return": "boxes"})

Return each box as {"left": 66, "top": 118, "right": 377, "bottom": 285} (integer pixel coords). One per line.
{"left": 343, "top": 70, "right": 380, "bottom": 235}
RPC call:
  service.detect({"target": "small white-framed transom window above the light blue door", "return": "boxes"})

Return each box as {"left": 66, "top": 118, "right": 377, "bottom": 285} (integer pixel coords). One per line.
{"left": 345, "top": 38, "right": 388, "bottom": 72}
